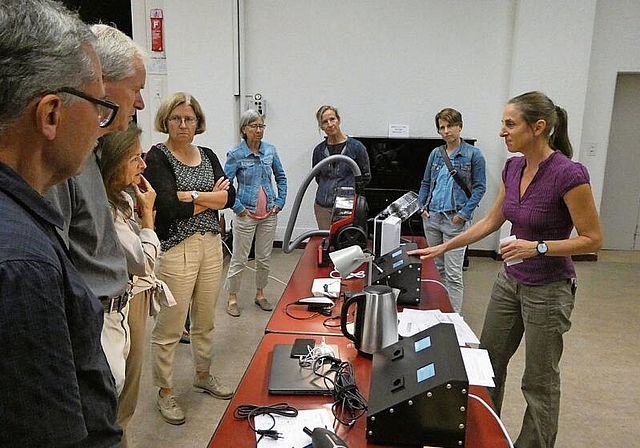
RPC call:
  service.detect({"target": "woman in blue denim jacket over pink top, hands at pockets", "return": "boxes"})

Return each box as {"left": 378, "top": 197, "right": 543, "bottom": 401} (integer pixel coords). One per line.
{"left": 224, "top": 109, "right": 287, "bottom": 317}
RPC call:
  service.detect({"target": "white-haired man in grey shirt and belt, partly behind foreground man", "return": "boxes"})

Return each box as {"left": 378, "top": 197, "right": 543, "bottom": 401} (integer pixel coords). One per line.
{"left": 46, "top": 24, "right": 146, "bottom": 424}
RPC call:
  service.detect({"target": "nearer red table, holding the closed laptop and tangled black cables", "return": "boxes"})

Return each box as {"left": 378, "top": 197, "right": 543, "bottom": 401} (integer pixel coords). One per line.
{"left": 208, "top": 333, "right": 507, "bottom": 448}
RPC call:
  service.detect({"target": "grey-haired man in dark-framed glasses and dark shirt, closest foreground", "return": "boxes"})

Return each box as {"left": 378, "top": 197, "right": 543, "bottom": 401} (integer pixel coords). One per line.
{"left": 0, "top": 0, "right": 121, "bottom": 447}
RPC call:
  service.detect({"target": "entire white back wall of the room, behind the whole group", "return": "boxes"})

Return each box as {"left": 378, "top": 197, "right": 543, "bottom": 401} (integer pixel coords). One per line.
{"left": 133, "top": 0, "right": 640, "bottom": 249}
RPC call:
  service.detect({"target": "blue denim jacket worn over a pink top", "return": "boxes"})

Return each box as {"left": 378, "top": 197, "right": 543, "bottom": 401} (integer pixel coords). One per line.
{"left": 224, "top": 140, "right": 287, "bottom": 214}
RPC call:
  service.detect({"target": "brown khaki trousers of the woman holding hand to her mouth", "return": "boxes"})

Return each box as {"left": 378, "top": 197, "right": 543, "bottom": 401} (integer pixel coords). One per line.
{"left": 116, "top": 289, "right": 152, "bottom": 448}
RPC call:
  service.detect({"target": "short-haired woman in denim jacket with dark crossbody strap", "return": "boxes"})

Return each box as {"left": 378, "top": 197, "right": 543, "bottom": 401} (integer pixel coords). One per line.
{"left": 419, "top": 108, "right": 487, "bottom": 313}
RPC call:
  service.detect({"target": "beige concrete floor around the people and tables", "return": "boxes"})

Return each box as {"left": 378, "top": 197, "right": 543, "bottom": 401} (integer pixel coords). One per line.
{"left": 129, "top": 249, "right": 640, "bottom": 448}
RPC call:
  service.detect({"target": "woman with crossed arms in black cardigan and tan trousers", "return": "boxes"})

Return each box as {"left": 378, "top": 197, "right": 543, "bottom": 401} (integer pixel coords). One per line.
{"left": 145, "top": 92, "right": 235, "bottom": 425}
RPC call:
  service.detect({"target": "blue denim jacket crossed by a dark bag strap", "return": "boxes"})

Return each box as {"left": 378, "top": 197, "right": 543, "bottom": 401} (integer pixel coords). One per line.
{"left": 419, "top": 140, "right": 487, "bottom": 221}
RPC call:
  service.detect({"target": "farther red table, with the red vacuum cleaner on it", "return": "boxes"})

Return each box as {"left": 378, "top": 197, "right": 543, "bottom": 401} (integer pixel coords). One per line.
{"left": 265, "top": 237, "right": 453, "bottom": 335}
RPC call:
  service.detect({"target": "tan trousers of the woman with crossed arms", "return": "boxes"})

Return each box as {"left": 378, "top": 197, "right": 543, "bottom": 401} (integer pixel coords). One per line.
{"left": 151, "top": 232, "right": 223, "bottom": 389}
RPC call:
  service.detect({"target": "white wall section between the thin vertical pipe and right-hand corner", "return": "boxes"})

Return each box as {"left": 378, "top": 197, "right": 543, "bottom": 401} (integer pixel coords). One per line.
{"left": 245, "top": 0, "right": 510, "bottom": 248}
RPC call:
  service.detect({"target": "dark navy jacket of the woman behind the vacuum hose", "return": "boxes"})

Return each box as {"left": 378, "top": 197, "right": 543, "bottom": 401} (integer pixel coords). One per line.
{"left": 312, "top": 137, "right": 371, "bottom": 207}
